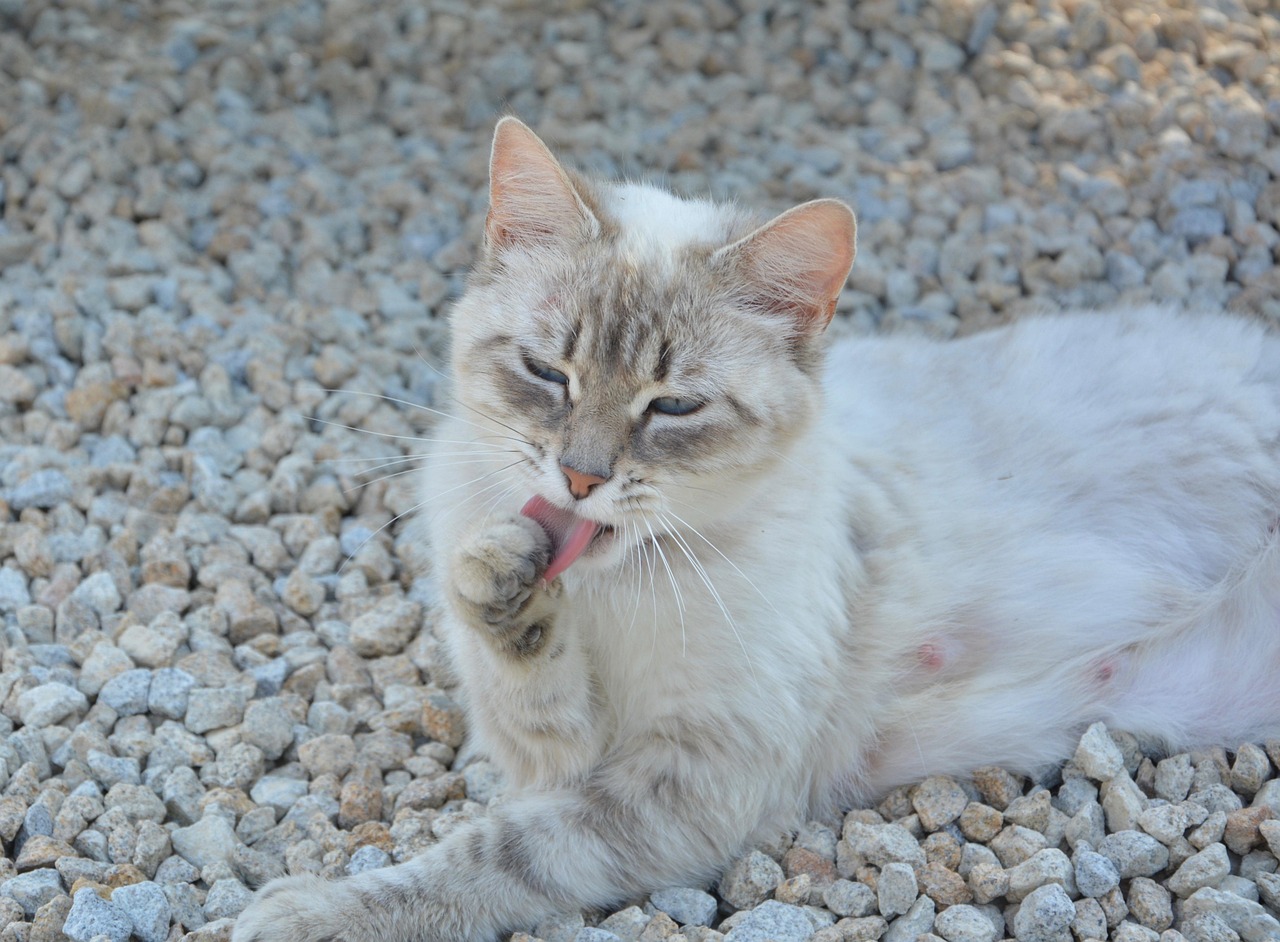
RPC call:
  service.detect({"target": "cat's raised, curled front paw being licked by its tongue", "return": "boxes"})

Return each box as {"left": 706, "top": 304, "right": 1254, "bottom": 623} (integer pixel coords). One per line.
{"left": 453, "top": 515, "right": 552, "bottom": 645}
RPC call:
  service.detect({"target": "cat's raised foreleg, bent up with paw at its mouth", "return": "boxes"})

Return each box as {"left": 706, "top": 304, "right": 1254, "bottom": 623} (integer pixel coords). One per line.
{"left": 447, "top": 515, "right": 608, "bottom": 785}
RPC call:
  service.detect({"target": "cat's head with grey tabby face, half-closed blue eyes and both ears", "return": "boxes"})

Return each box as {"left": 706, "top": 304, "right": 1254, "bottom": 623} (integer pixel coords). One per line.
{"left": 452, "top": 118, "right": 855, "bottom": 563}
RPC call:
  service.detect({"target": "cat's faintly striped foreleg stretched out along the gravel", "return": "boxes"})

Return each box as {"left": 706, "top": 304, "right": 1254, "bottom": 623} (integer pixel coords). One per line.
{"left": 232, "top": 728, "right": 778, "bottom": 942}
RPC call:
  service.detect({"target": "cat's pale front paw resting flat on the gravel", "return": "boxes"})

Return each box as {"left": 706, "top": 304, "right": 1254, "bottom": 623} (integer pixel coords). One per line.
{"left": 232, "top": 875, "right": 384, "bottom": 942}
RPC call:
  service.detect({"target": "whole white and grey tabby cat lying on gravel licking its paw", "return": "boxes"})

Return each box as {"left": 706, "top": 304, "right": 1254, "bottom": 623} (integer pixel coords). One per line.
{"left": 233, "top": 118, "right": 1280, "bottom": 942}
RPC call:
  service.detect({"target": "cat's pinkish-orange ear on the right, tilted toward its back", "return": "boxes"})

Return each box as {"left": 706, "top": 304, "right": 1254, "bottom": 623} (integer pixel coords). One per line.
{"left": 716, "top": 200, "right": 858, "bottom": 330}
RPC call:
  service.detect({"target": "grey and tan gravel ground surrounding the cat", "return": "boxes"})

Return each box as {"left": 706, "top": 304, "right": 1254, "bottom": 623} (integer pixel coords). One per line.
{"left": 0, "top": 0, "right": 1280, "bottom": 942}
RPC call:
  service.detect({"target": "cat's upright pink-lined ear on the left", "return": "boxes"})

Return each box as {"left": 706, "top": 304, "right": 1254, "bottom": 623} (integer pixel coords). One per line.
{"left": 485, "top": 116, "right": 600, "bottom": 250}
